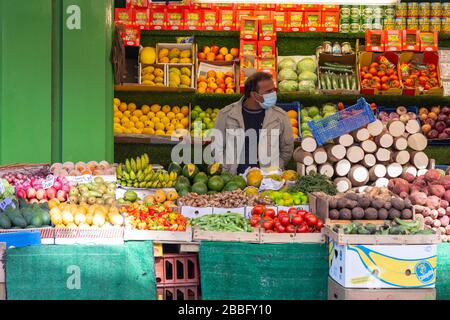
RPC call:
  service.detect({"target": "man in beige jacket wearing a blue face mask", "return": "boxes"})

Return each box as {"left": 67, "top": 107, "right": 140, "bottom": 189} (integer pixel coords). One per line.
{"left": 213, "top": 72, "right": 294, "bottom": 174}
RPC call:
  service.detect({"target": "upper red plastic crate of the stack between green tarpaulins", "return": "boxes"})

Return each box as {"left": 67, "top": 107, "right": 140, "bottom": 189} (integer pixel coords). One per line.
{"left": 155, "top": 254, "right": 200, "bottom": 286}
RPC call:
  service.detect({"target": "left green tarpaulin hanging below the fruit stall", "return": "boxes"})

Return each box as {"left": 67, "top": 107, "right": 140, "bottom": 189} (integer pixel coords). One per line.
{"left": 6, "top": 242, "right": 156, "bottom": 300}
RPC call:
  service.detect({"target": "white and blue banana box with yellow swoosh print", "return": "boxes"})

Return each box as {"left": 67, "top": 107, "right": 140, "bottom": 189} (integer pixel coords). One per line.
{"left": 329, "top": 241, "right": 437, "bottom": 289}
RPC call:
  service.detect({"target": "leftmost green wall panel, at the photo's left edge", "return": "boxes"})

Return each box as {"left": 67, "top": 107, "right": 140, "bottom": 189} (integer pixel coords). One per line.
{"left": 0, "top": 0, "right": 52, "bottom": 164}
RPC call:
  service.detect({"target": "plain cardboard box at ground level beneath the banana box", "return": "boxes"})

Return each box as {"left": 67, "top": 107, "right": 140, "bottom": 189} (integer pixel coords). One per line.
{"left": 328, "top": 277, "right": 436, "bottom": 300}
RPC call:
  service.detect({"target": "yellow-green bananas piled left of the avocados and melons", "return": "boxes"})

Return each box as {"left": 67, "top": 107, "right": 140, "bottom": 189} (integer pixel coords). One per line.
{"left": 117, "top": 153, "right": 177, "bottom": 189}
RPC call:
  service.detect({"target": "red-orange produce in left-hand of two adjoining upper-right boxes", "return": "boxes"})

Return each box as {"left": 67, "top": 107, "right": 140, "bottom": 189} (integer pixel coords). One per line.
{"left": 360, "top": 55, "right": 401, "bottom": 91}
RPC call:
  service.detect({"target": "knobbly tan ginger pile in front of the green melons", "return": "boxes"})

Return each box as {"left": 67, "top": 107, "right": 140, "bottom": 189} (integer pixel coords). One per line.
{"left": 178, "top": 190, "right": 273, "bottom": 208}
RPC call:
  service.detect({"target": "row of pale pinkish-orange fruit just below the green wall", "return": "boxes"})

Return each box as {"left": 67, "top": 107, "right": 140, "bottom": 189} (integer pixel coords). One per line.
{"left": 50, "top": 161, "right": 116, "bottom": 176}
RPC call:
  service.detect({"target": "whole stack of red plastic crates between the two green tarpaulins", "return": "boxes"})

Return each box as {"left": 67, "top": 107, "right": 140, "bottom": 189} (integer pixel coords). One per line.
{"left": 155, "top": 254, "right": 200, "bottom": 300}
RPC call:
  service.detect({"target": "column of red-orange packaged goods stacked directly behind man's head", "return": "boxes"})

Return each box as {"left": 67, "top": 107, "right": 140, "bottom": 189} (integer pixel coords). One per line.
{"left": 239, "top": 17, "right": 277, "bottom": 93}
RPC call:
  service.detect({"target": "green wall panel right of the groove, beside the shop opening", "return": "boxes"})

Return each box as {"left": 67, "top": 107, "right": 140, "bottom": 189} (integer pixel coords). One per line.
{"left": 61, "top": 0, "right": 114, "bottom": 161}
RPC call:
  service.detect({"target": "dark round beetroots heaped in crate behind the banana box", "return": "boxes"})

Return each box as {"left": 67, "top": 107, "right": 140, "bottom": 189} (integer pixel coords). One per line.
{"left": 328, "top": 188, "right": 413, "bottom": 220}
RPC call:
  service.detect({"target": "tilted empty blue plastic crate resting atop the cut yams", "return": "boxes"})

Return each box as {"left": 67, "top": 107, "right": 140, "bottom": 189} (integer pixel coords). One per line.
{"left": 308, "top": 98, "right": 376, "bottom": 145}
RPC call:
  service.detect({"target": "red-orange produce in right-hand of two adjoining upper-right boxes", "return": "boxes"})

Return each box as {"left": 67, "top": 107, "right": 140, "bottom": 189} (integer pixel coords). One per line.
{"left": 400, "top": 61, "right": 439, "bottom": 91}
